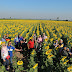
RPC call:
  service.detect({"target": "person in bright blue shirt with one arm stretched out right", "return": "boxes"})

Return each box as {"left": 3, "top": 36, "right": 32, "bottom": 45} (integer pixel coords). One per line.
{"left": 7, "top": 41, "right": 21, "bottom": 68}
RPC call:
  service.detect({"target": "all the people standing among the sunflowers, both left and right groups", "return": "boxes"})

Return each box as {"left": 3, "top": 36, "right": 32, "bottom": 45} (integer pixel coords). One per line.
{"left": 1, "top": 33, "right": 72, "bottom": 70}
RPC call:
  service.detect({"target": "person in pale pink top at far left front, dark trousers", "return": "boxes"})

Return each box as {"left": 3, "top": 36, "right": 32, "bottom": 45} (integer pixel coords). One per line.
{"left": 1, "top": 43, "right": 9, "bottom": 70}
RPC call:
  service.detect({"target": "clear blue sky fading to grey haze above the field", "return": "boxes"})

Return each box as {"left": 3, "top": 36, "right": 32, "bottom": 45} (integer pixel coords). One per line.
{"left": 0, "top": 0, "right": 72, "bottom": 20}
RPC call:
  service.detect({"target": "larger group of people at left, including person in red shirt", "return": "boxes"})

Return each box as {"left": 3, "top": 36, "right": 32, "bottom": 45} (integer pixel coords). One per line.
{"left": 1, "top": 33, "right": 47, "bottom": 70}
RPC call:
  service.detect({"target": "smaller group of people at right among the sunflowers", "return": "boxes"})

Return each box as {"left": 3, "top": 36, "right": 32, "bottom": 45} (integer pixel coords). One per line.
{"left": 53, "top": 39, "right": 72, "bottom": 57}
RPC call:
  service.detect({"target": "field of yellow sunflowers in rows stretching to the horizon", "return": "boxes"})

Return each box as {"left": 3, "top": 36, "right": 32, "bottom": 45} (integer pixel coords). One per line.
{"left": 0, "top": 20, "right": 72, "bottom": 72}
